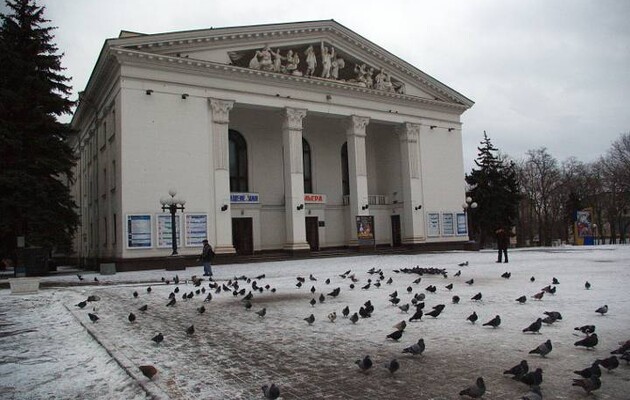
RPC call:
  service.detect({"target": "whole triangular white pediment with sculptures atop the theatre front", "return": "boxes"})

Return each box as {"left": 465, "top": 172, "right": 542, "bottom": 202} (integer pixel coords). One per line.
{"left": 109, "top": 20, "right": 473, "bottom": 108}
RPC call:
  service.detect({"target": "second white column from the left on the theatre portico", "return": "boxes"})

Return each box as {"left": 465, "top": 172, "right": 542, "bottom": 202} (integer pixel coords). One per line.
{"left": 282, "top": 108, "right": 310, "bottom": 251}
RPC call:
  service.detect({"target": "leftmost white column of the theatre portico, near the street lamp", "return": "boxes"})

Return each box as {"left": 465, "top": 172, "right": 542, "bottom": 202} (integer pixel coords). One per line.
{"left": 208, "top": 99, "right": 235, "bottom": 254}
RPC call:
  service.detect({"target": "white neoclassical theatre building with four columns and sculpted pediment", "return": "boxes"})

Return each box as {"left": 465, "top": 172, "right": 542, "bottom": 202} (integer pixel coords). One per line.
{"left": 72, "top": 21, "right": 473, "bottom": 268}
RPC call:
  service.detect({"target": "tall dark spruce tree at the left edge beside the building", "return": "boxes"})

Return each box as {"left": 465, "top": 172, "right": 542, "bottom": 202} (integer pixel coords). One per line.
{"left": 0, "top": 0, "right": 78, "bottom": 259}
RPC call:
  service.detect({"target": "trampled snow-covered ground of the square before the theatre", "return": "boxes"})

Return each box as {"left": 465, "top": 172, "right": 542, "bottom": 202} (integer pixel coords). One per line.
{"left": 0, "top": 246, "right": 630, "bottom": 400}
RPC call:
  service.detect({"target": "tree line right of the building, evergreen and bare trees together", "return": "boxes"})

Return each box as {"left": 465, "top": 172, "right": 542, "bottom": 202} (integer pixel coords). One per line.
{"left": 466, "top": 132, "right": 630, "bottom": 246}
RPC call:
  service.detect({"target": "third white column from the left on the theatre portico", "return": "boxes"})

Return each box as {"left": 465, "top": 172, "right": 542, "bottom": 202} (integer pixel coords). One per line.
{"left": 346, "top": 115, "right": 370, "bottom": 246}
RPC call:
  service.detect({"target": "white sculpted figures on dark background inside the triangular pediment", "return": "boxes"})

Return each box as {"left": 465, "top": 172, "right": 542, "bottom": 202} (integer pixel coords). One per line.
{"left": 228, "top": 42, "right": 405, "bottom": 94}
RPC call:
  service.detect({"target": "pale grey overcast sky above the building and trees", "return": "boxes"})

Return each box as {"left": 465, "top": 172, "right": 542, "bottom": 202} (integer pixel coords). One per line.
{"left": 1, "top": 0, "right": 630, "bottom": 172}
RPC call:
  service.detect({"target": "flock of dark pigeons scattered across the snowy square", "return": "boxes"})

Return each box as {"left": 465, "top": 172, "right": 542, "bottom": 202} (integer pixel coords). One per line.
{"left": 71, "top": 262, "right": 630, "bottom": 400}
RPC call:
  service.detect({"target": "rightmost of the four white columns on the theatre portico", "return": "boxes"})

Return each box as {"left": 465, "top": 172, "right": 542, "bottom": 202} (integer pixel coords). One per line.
{"left": 397, "top": 122, "right": 425, "bottom": 244}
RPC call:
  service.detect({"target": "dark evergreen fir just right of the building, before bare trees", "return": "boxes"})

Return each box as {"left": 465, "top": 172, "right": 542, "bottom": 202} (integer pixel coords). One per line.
{"left": 466, "top": 131, "right": 521, "bottom": 247}
